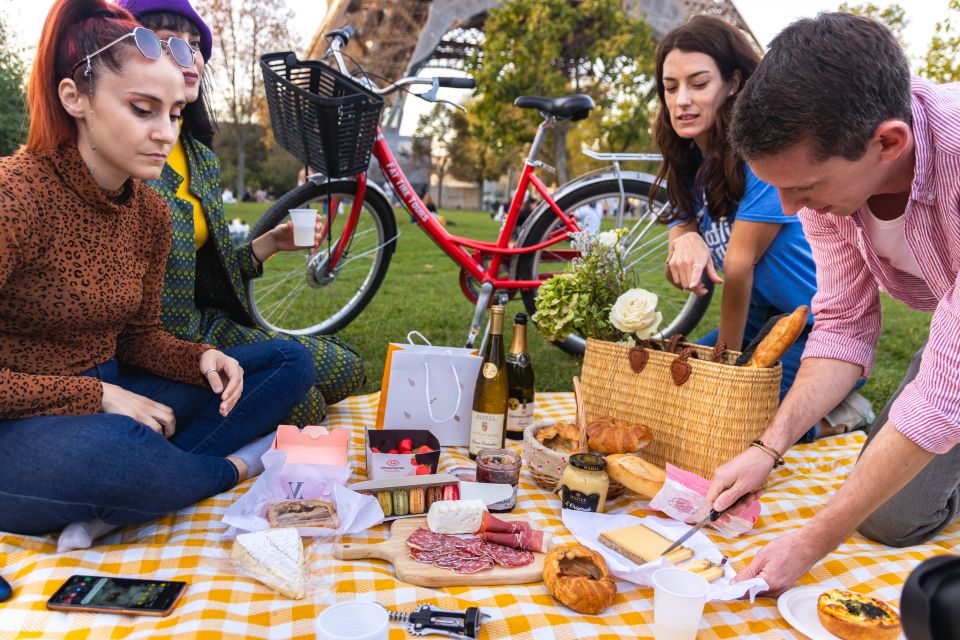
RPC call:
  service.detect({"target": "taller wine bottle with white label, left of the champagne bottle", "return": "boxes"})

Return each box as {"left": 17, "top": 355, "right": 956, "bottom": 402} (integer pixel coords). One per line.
{"left": 470, "top": 305, "right": 507, "bottom": 460}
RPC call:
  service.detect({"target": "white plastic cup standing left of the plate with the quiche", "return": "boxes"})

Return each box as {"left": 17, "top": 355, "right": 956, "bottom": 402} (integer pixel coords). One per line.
{"left": 653, "top": 568, "right": 710, "bottom": 640}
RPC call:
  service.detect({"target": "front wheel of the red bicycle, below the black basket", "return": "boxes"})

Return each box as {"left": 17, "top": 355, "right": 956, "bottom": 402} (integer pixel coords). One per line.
{"left": 247, "top": 180, "right": 397, "bottom": 335}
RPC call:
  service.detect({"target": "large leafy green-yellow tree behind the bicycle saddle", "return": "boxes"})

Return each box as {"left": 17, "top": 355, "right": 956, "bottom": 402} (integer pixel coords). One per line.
{"left": 467, "top": 0, "right": 656, "bottom": 182}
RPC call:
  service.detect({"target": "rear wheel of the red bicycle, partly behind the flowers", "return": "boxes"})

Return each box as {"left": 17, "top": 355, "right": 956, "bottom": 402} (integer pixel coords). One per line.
{"left": 517, "top": 178, "right": 713, "bottom": 355}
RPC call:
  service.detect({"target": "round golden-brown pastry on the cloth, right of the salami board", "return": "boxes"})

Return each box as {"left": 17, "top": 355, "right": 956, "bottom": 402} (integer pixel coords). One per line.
{"left": 543, "top": 544, "right": 617, "bottom": 615}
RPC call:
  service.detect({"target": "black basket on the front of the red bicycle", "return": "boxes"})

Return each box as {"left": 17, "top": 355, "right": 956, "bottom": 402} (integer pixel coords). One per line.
{"left": 260, "top": 51, "right": 383, "bottom": 178}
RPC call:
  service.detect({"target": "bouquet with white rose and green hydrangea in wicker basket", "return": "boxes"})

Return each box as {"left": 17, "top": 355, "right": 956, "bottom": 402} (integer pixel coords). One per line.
{"left": 533, "top": 230, "right": 663, "bottom": 342}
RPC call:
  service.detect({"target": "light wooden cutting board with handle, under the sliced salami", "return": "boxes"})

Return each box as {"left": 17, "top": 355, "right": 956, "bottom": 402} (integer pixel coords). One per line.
{"left": 334, "top": 514, "right": 545, "bottom": 587}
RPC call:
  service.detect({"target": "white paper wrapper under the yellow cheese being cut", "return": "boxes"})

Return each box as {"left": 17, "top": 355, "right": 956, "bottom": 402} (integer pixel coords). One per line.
{"left": 563, "top": 509, "right": 769, "bottom": 602}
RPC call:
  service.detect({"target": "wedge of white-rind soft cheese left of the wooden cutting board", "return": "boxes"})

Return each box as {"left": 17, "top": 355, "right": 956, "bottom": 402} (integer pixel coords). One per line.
{"left": 230, "top": 528, "right": 307, "bottom": 600}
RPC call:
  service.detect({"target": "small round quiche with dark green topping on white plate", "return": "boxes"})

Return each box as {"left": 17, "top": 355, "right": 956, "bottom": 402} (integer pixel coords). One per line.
{"left": 817, "top": 589, "right": 900, "bottom": 640}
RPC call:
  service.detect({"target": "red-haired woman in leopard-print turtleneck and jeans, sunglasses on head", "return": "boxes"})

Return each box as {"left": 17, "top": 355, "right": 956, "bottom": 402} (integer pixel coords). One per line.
{"left": 0, "top": 0, "right": 314, "bottom": 546}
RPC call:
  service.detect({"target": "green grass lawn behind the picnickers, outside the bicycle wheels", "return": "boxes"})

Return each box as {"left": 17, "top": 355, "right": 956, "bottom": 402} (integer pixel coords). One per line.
{"left": 225, "top": 203, "right": 930, "bottom": 411}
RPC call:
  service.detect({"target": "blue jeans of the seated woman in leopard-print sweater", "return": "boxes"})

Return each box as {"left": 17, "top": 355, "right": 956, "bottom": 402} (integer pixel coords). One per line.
{"left": 0, "top": 340, "right": 316, "bottom": 535}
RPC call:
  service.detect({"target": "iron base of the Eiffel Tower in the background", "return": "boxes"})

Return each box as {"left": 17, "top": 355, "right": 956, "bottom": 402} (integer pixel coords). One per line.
{"left": 306, "top": 0, "right": 762, "bottom": 89}
